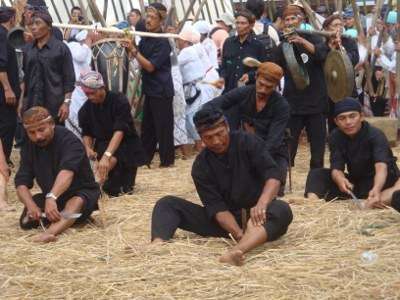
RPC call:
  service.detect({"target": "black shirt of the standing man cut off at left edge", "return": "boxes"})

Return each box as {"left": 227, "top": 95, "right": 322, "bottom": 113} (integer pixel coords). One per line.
{"left": 0, "top": 25, "right": 21, "bottom": 105}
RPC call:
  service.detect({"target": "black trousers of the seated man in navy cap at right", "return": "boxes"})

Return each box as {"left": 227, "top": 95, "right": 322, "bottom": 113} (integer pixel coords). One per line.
{"left": 305, "top": 168, "right": 398, "bottom": 201}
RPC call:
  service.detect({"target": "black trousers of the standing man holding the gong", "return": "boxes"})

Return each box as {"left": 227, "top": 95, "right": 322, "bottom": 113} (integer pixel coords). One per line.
{"left": 289, "top": 113, "right": 326, "bottom": 169}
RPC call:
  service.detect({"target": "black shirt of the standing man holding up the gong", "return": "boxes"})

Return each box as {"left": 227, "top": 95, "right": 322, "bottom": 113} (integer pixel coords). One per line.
{"left": 274, "top": 35, "right": 329, "bottom": 115}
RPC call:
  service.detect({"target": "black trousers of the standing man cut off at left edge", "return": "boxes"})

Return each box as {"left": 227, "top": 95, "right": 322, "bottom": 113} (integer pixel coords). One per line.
{"left": 0, "top": 103, "right": 17, "bottom": 161}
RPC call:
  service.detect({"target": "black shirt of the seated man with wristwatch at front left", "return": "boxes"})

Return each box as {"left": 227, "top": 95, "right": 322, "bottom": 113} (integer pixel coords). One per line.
{"left": 15, "top": 126, "right": 99, "bottom": 197}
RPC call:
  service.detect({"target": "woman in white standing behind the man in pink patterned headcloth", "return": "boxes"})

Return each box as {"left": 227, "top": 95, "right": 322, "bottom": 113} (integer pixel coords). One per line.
{"left": 65, "top": 30, "right": 92, "bottom": 138}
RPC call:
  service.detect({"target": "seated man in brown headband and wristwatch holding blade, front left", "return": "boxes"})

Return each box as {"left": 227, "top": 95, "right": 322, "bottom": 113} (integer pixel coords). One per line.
{"left": 15, "top": 106, "right": 100, "bottom": 243}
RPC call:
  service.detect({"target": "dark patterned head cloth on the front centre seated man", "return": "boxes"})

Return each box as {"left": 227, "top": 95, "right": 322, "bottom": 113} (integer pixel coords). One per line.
{"left": 193, "top": 107, "right": 226, "bottom": 134}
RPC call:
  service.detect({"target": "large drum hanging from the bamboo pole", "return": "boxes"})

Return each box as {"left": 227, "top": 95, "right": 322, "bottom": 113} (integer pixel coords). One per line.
{"left": 92, "top": 38, "right": 129, "bottom": 94}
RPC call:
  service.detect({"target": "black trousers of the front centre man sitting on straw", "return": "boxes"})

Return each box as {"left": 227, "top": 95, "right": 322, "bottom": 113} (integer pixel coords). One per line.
{"left": 151, "top": 196, "right": 293, "bottom": 241}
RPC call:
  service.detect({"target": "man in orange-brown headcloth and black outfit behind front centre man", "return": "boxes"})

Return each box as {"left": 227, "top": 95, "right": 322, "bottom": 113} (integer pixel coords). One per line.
{"left": 204, "top": 62, "right": 290, "bottom": 191}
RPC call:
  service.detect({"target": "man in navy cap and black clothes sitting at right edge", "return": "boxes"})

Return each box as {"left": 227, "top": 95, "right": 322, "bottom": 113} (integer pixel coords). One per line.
{"left": 305, "top": 98, "right": 400, "bottom": 208}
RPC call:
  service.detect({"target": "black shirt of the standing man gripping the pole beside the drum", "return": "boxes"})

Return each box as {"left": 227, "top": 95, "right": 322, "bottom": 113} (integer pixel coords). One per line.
{"left": 139, "top": 37, "right": 174, "bottom": 98}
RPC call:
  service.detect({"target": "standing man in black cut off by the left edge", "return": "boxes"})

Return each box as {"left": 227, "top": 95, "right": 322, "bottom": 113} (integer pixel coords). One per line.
{"left": 0, "top": 7, "right": 21, "bottom": 162}
